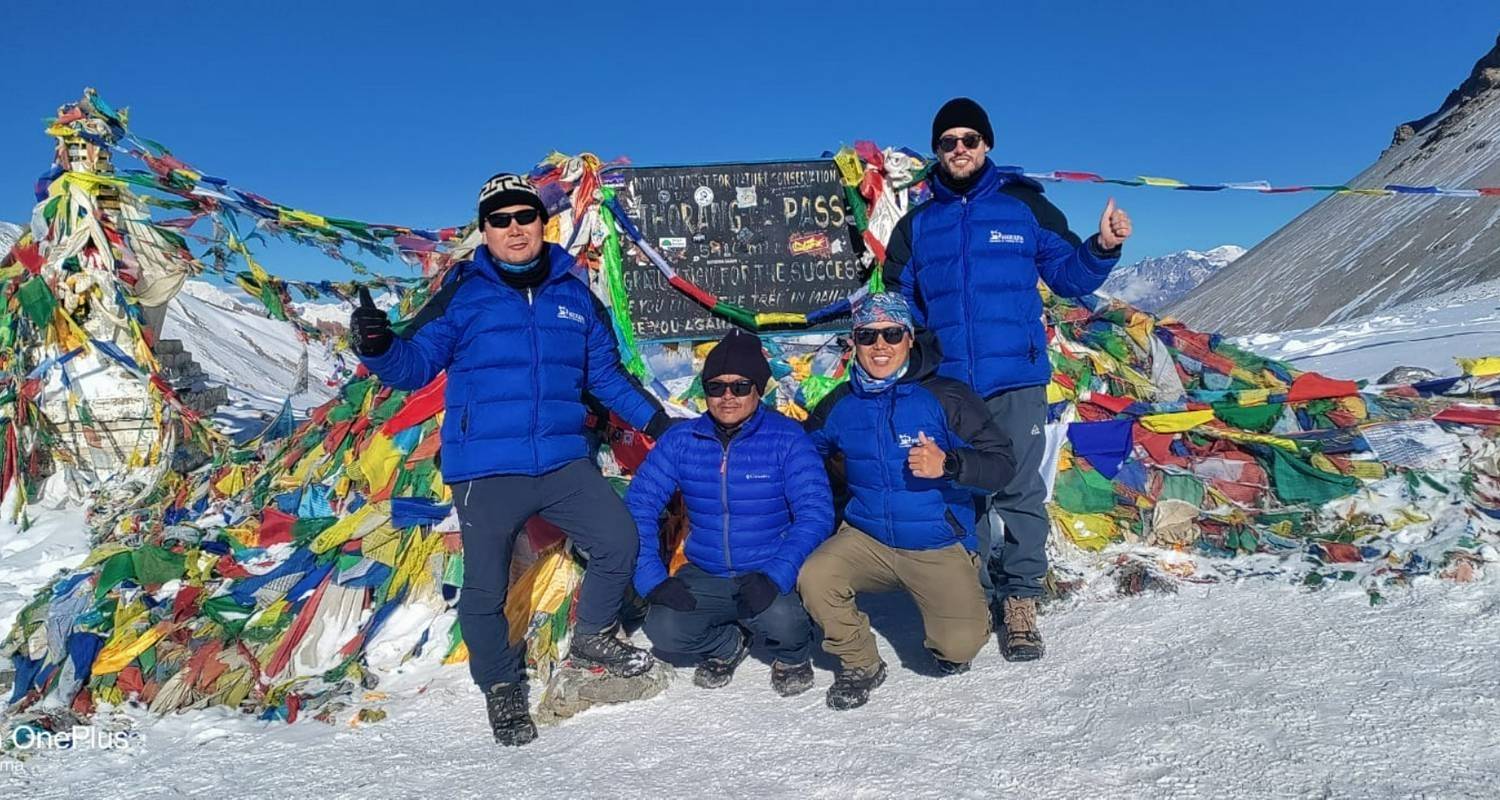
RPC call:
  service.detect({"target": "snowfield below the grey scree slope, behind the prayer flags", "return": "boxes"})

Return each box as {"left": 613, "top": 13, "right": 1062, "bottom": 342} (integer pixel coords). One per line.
{"left": 1235, "top": 281, "right": 1500, "bottom": 380}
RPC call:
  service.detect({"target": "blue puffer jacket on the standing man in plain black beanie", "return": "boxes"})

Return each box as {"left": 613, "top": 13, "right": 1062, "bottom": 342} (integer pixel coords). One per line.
{"left": 884, "top": 161, "right": 1119, "bottom": 398}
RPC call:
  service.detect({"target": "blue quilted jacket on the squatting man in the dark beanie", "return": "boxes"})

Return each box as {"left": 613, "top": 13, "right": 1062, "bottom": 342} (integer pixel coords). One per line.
{"left": 626, "top": 405, "right": 834, "bottom": 596}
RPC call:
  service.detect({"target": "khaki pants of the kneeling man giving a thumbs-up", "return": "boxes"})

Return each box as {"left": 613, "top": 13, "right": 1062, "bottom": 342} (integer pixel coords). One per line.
{"left": 797, "top": 524, "right": 990, "bottom": 669}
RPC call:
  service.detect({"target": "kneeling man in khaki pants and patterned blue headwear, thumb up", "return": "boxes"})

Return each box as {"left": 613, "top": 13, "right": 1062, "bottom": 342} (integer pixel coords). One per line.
{"left": 798, "top": 293, "right": 1016, "bottom": 710}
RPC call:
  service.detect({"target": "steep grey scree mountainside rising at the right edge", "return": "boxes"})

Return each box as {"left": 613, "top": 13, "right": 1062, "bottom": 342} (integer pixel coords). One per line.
{"left": 1167, "top": 34, "right": 1500, "bottom": 335}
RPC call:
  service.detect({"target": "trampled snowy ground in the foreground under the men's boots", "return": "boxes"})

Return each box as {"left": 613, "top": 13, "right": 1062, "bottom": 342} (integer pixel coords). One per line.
{"left": 0, "top": 581, "right": 1500, "bottom": 798}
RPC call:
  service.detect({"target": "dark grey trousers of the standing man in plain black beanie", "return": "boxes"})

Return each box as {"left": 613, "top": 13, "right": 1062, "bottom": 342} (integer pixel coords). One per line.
{"left": 975, "top": 386, "right": 1052, "bottom": 602}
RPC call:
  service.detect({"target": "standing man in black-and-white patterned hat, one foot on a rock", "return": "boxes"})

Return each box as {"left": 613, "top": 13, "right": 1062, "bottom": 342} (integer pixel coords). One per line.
{"left": 350, "top": 173, "right": 669, "bottom": 744}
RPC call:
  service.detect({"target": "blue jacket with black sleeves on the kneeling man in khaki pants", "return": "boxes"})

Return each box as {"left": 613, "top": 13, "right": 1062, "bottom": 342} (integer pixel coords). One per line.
{"left": 807, "top": 330, "right": 1016, "bottom": 551}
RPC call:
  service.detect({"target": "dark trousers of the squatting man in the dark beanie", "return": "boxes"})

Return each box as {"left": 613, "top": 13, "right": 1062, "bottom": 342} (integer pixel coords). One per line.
{"left": 645, "top": 564, "right": 813, "bottom": 663}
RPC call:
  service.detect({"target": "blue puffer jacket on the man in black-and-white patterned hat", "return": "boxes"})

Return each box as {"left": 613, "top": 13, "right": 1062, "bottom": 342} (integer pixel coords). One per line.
{"left": 362, "top": 245, "right": 662, "bottom": 483}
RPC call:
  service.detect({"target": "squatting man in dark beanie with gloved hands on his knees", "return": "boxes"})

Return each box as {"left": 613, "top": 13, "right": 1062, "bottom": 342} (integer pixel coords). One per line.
{"left": 626, "top": 329, "right": 834, "bottom": 696}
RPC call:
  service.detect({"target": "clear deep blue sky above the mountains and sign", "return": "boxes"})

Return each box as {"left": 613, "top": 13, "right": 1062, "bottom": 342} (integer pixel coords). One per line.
{"left": 0, "top": 0, "right": 1500, "bottom": 278}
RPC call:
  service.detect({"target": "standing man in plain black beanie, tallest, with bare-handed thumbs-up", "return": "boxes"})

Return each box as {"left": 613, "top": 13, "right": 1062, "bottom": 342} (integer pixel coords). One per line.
{"left": 884, "top": 98, "right": 1131, "bottom": 660}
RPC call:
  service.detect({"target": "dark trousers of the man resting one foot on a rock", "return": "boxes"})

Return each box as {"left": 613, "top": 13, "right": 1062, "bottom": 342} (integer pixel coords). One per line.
{"left": 453, "top": 461, "right": 641, "bottom": 689}
